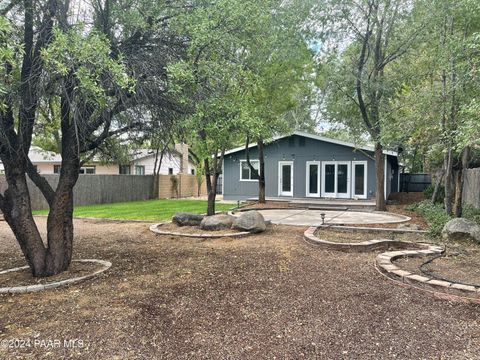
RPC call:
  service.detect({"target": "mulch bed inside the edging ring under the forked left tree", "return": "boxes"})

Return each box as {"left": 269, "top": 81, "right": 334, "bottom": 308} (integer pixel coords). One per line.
{"left": 0, "top": 262, "right": 102, "bottom": 287}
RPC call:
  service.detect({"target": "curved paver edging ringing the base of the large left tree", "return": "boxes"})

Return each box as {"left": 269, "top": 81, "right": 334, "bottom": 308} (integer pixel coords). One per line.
{"left": 0, "top": 259, "right": 112, "bottom": 294}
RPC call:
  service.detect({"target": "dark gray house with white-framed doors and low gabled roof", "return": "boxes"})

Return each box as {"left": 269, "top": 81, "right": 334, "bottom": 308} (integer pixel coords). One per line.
{"left": 222, "top": 131, "right": 400, "bottom": 200}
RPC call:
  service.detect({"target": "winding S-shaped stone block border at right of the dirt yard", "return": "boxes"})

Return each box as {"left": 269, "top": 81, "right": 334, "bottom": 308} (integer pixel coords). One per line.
{"left": 304, "top": 226, "right": 480, "bottom": 300}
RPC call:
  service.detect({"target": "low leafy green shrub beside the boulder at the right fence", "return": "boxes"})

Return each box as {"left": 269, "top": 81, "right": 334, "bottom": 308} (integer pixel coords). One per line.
{"left": 407, "top": 200, "right": 480, "bottom": 237}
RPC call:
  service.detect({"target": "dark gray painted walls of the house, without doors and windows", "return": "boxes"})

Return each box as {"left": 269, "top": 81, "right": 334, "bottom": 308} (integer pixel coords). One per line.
{"left": 223, "top": 135, "right": 398, "bottom": 200}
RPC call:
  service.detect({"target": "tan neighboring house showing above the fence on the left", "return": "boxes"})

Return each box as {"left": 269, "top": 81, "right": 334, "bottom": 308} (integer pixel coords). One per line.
{"left": 0, "top": 144, "right": 195, "bottom": 175}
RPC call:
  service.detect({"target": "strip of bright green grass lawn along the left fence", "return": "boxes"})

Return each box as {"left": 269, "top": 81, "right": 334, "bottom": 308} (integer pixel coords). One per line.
{"left": 34, "top": 199, "right": 235, "bottom": 220}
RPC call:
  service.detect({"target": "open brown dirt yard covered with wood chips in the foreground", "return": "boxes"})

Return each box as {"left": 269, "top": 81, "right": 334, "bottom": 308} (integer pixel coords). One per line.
{"left": 0, "top": 219, "right": 480, "bottom": 359}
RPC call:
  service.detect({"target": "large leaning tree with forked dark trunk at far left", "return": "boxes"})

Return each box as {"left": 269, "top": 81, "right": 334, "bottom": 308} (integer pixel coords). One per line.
{"left": 0, "top": 0, "right": 188, "bottom": 277}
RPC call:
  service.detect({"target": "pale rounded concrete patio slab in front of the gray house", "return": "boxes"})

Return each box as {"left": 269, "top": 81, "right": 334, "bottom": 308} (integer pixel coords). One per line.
{"left": 251, "top": 209, "right": 410, "bottom": 226}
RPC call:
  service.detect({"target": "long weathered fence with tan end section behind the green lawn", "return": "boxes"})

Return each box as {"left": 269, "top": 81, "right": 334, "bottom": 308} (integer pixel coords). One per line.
{"left": 0, "top": 174, "right": 207, "bottom": 210}
